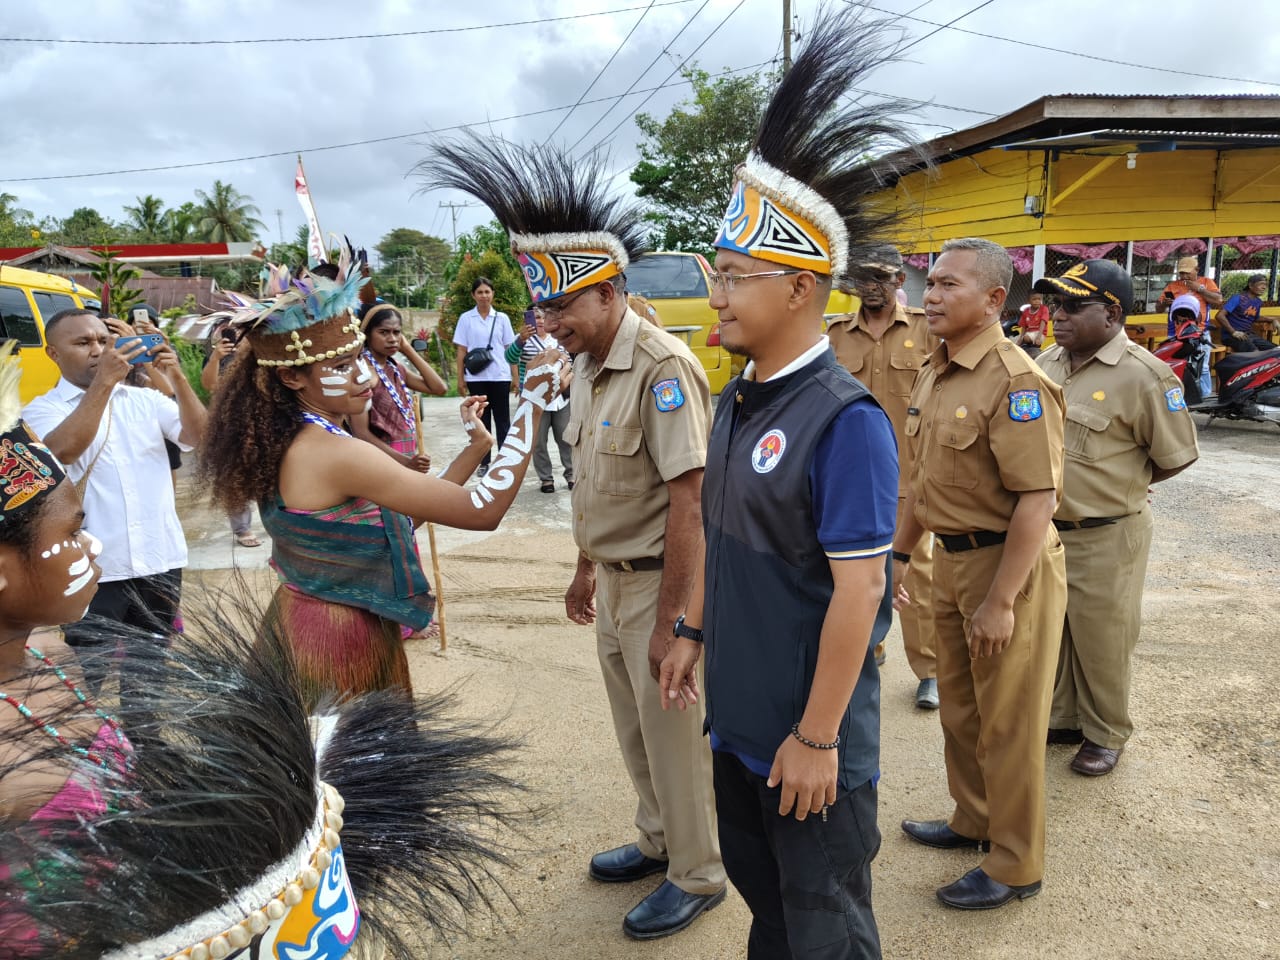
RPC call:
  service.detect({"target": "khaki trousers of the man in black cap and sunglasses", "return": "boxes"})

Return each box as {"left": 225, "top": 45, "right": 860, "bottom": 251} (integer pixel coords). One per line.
{"left": 1048, "top": 507, "right": 1153, "bottom": 750}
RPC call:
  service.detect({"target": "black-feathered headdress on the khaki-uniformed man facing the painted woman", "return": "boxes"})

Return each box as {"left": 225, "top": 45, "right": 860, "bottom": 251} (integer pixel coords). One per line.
{"left": 416, "top": 132, "right": 645, "bottom": 303}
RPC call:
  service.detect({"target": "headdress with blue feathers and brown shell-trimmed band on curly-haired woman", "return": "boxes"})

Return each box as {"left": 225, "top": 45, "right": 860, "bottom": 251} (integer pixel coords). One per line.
{"left": 228, "top": 238, "right": 369, "bottom": 366}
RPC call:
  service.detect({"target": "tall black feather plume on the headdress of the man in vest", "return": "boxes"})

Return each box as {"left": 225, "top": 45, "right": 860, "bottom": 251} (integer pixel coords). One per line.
{"left": 751, "top": 5, "right": 927, "bottom": 273}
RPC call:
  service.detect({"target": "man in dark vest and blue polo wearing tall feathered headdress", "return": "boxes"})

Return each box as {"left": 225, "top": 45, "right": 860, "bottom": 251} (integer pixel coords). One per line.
{"left": 659, "top": 17, "right": 897, "bottom": 960}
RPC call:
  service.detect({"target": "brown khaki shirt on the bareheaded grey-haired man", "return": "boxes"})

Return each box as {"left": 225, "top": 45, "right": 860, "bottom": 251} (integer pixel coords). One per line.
{"left": 905, "top": 323, "right": 1062, "bottom": 534}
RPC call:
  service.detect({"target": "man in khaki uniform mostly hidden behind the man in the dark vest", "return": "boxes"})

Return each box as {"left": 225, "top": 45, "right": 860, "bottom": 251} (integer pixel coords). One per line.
{"left": 827, "top": 244, "right": 938, "bottom": 710}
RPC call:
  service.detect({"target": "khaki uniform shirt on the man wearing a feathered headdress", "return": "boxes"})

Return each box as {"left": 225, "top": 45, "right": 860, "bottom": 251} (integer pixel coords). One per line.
{"left": 564, "top": 310, "right": 712, "bottom": 563}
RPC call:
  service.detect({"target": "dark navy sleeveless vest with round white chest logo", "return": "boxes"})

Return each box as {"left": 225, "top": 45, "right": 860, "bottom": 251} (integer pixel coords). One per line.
{"left": 703, "top": 349, "right": 892, "bottom": 791}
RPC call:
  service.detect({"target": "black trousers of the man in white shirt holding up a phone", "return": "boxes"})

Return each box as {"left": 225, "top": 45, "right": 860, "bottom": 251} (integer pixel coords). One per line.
{"left": 64, "top": 568, "right": 182, "bottom": 707}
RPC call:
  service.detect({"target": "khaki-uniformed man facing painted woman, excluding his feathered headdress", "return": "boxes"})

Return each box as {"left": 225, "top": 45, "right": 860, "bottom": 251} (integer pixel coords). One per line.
{"left": 560, "top": 293, "right": 724, "bottom": 938}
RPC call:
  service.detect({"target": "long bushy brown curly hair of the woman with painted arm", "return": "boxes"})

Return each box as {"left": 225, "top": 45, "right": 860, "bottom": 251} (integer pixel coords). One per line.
{"left": 200, "top": 349, "right": 302, "bottom": 511}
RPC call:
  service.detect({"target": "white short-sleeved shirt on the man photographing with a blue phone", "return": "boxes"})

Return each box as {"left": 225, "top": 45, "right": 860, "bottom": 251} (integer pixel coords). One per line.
{"left": 22, "top": 380, "right": 191, "bottom": 584}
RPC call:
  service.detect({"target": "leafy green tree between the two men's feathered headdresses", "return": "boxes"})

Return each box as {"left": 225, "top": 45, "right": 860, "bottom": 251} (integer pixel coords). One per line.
{"left": 631, "top": 68, "right": 774, "bottom": 253}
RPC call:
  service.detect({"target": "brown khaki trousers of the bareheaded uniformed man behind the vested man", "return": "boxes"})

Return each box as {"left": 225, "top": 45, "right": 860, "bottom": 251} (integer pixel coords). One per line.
{"left": 933, "top": 526, "right": 1066, "bottom": 886}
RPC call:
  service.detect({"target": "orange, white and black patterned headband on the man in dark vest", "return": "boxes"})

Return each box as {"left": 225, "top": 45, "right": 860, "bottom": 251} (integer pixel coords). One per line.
{"left": 713, "top": 156, "right": 849, "bottom": 274}
